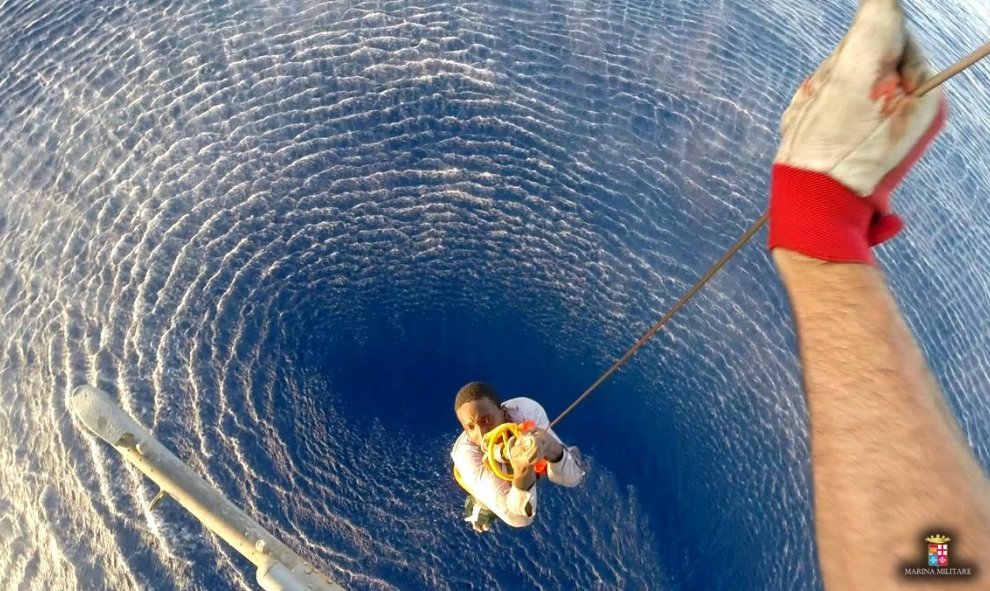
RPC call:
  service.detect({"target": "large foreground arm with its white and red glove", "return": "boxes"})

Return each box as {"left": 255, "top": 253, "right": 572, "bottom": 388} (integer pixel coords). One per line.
{"left": 769, "top": 0, "right": 990, "bottom": 591}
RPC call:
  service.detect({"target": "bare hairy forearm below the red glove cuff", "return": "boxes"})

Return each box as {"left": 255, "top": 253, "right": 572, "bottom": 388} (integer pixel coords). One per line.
{"left": 774, "top": 248, "right": 990, "bottom": 589}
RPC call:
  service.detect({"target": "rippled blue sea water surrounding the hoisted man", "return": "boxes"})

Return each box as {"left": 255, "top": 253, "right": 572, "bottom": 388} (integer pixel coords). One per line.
{"left": 0, "top": 0, "right": 990, "bottom": 590}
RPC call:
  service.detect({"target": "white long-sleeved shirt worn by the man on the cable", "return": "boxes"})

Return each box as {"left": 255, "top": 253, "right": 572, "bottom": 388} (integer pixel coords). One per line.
{"left": 450, "top": 397, "right": 584, "bottom": 527}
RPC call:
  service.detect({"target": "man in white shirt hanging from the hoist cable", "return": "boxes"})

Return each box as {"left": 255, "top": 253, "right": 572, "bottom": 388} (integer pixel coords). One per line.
{"left": 450, "top": 382, "right": 584, "bottom": 532}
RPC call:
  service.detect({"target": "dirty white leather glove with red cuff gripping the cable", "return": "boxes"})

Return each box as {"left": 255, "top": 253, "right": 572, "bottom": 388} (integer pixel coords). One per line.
{"left": 770, "top": 0, "right": 945, "bottom": 264}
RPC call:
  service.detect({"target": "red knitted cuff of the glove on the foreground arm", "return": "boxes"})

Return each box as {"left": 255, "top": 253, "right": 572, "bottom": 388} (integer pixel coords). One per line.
{"left": 770, "top": 164, "right": 888, "bottom": 265}
